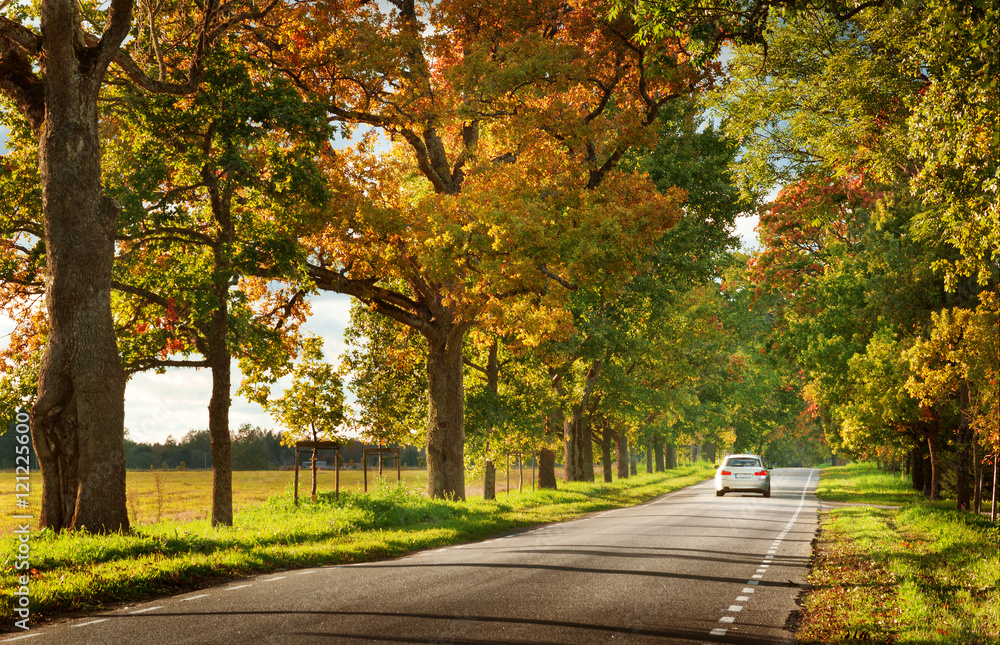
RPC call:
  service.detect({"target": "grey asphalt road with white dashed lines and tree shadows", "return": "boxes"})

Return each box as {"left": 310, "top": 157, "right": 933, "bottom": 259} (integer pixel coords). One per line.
{"left": 0, "top": 469, "right": 818, "bottom": 645}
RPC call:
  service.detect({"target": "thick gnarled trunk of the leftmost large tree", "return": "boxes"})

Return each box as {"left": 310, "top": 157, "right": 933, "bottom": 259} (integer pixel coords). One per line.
{"left": 28, "top": 10, "right": 130, "bottom": 533}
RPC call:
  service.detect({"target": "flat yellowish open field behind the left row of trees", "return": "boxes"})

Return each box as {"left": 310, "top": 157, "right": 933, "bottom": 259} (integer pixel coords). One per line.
{"left": 0, "top": 467, "right": 556, "bottom": 537}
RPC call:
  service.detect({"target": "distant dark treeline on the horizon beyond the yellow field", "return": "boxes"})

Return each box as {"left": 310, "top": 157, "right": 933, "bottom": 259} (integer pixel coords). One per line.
{"left": 123, "top": 424, "right": 427, "bottom": 470}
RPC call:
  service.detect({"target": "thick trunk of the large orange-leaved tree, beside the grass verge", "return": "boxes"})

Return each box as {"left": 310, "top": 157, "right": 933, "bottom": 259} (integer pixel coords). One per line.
{"left": 427, "top": 325, "right": 466, "bottom": 500}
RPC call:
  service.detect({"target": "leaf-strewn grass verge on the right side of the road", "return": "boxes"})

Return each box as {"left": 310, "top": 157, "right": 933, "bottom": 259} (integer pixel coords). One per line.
{"left": 796, "top": 465, "right": 1000, "bottom": 645}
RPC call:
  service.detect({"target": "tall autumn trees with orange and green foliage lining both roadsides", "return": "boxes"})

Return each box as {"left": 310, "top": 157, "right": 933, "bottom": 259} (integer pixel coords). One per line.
{"left": 0, "top": 0, "right": 1000, "bottom": 531}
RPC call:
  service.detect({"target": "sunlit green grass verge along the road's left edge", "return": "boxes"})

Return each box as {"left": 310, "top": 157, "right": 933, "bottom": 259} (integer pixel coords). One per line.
{"left": 0, "top": 464, "right": 713, "bottom": 624}
